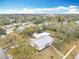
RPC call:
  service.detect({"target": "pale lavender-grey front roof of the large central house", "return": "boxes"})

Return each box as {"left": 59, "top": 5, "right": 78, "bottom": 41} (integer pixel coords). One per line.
{"left": 34, "top": 36, "right": 54, "bottom": 47}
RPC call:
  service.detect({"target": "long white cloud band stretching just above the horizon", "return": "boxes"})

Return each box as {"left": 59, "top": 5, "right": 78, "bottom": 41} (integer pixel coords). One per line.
{"left": 0, "top": 5, "right": 79, "bottom": 14}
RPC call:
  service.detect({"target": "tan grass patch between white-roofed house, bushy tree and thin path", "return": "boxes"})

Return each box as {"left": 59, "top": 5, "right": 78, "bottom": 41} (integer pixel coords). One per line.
{"left": 32, "top": 47, "right": 61, "bottom": 59}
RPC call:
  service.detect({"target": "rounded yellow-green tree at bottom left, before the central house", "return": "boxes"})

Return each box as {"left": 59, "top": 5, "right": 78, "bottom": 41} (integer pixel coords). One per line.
{"left": 7, "top": 43, "right": 36, "bottom": 59}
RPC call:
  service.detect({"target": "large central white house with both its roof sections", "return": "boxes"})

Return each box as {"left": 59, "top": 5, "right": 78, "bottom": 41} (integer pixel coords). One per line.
{"left": 30, "top": 32, "right": 54, "bottom": 51}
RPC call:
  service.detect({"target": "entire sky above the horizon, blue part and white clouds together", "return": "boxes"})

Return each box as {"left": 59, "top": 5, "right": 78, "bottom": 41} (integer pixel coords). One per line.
{"left": 0, "top": 0, "right": 79, "bottom": 14}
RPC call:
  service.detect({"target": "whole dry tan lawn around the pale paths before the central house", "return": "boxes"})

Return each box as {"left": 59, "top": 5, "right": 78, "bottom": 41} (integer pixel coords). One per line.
{"left": 34, "top": 41, "right": 79, "bottom": 59}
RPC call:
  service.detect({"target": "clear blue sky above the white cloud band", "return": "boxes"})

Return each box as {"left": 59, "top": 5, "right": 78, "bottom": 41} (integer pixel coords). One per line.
{"left": 0, "top": 0, "right": 79, "bottom": 9}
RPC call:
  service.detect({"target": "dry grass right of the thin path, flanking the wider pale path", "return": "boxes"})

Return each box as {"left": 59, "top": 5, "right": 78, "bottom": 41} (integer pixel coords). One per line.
{"left": 53, "top": 41, "right": 79, "bottom": 59}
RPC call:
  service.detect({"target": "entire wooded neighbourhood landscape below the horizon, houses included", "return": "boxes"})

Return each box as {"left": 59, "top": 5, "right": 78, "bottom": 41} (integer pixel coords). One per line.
{"left": 0, "top": 15, "right": 79, "bottom": 59}
